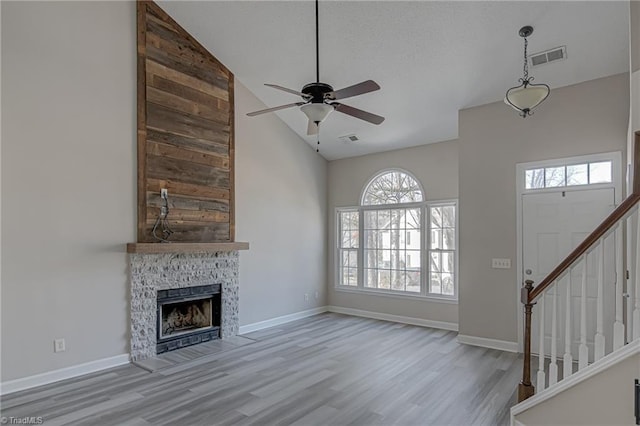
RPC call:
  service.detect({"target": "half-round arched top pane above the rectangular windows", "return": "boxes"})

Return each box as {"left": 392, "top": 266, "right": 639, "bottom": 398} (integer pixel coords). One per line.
{"left": 362, "top": 170, "right": 423, "bottom": 206}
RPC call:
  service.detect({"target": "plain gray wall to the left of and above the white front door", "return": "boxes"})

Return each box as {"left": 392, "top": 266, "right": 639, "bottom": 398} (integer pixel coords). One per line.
{"left": 458, "top": 74, "right": 629, "bottom": 342}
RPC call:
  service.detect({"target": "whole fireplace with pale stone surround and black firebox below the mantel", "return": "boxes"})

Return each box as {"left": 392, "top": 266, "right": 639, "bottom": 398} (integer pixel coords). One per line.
{"left": 129, "top": 251, "right": 239, "bottom": 361}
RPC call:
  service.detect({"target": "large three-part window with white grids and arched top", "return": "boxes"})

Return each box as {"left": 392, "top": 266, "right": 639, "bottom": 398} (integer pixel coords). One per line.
{"left": 336, "top": 170, "right": 457, "bottom": 298}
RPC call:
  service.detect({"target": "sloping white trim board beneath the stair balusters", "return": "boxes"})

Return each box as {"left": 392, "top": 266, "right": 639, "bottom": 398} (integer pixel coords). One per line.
{"left": 511, "top": 340, "right": 640, "bottom": 420}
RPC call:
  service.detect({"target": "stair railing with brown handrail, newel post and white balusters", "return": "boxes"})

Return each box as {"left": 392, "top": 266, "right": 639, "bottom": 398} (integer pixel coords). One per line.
{"left": 518, "top": 133, "right": 640, "bottom": 402}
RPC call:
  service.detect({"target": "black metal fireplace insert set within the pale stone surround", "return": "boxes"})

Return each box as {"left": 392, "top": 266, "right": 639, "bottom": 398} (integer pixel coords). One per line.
{"left": 156, "top": 284, "right": 221, "bottom": 354}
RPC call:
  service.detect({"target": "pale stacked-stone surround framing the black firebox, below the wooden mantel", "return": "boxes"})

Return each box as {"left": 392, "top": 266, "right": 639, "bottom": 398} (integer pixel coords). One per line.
{"left": 129, "top": 251, "right": 239, "bottom": 361}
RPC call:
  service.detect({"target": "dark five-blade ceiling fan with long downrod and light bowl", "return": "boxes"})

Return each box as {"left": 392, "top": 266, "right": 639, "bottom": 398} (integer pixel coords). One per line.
{"left": 247, "top": 0, "right": 384, "bottom": 135}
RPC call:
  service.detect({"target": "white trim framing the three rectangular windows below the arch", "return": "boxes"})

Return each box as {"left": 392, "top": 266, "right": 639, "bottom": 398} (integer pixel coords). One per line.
{"left": 334, "top": 198, "right": 460, "bottom": 304}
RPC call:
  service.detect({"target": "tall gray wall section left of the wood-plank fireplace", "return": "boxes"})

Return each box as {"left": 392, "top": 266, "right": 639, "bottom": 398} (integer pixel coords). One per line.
{"left": 1, "top": 2, "right": 136, "bottom": 381}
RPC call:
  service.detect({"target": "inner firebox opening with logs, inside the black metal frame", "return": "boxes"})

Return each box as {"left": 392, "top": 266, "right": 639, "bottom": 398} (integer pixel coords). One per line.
{"left": 160, "top": 298, "right": 213, "bottom": 339}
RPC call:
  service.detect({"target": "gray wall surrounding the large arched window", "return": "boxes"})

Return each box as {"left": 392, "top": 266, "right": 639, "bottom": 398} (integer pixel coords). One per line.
{"left": 327, "top": 141, "right": 458, "bottom": 323}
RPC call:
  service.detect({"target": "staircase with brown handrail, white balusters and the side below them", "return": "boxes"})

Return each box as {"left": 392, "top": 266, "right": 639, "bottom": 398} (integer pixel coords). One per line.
{"left": 511, "top": 134, "right": 640, "bottom": 425}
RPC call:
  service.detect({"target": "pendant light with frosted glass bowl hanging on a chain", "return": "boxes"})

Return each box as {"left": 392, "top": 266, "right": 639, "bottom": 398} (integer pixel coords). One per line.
{"left": 504, "top": 25, "right": 551, "bottom": 118}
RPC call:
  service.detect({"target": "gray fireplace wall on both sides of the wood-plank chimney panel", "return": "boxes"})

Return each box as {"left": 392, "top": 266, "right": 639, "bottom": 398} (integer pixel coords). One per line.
{"left": 0, "top": 1, "right": 326, "bottom": 382}
